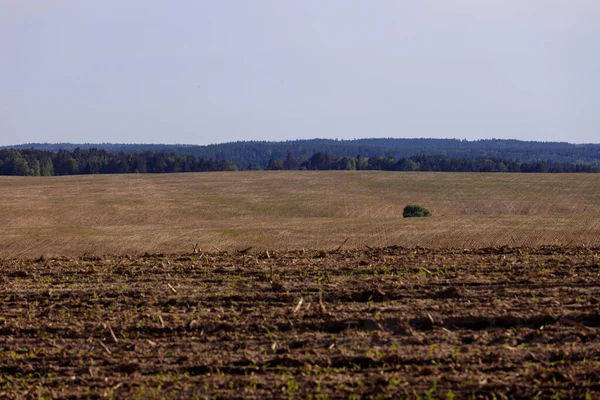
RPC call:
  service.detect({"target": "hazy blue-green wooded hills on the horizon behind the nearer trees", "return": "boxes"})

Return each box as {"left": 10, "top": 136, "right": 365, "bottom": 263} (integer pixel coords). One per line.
{"left": 6, "top": 138, "right": 600, "bottom": 169}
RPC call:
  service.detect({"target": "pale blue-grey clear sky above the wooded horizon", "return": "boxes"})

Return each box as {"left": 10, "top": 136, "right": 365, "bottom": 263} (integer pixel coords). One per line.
{"left": 0, "top": 0, "right": 600, "bottom": 145}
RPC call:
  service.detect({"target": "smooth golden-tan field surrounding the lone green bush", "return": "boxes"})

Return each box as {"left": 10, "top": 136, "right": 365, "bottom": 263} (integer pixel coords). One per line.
{"left": 0, "top": 171, "right": 600, "bottom": 258}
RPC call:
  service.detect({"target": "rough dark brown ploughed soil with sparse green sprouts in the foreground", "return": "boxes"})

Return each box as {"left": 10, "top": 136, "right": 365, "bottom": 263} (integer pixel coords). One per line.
{"left": 0, "top": 247, "right": 600, "bottom": 399}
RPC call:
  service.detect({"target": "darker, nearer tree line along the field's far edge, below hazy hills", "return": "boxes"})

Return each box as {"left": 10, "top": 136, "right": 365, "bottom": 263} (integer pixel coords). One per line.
{"left": 0, "top": 148, "right": 600, "bottom": 176}
